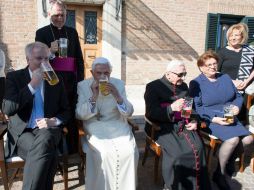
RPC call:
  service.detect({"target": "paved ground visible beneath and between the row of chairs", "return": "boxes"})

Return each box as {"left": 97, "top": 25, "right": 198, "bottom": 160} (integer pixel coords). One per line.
{"left": 0, "top": 119, "right": 254, "bottom": 190}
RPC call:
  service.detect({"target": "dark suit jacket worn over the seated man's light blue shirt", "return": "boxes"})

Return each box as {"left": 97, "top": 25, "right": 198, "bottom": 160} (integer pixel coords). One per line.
{"left": 3, "top": 67, "right": 70, "bottom": 157}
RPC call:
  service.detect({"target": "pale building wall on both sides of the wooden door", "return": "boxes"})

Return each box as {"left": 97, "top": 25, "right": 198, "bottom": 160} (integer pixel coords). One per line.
{"left": 0, "top": 0, "right": 254, "bottom": 85}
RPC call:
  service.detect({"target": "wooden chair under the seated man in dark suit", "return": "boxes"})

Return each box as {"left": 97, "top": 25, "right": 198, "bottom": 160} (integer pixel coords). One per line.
{"left": 0, "top": 120, "right": 68, "bottom": 190}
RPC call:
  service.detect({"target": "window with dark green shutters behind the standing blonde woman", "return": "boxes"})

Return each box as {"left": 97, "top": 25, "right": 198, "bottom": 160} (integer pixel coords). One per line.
{"left": 205, "top": 13, "right": 254, "bottom": 51}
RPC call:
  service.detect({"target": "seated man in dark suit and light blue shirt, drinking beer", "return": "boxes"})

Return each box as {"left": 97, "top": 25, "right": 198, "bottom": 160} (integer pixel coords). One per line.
{"left": 2, "top": 42, "right": 69, "bottom": 190}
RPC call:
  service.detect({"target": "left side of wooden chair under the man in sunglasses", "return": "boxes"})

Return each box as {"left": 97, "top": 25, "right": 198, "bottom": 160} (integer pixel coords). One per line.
{"left": 142, "top": 117, "right": 162, "bottom": 183}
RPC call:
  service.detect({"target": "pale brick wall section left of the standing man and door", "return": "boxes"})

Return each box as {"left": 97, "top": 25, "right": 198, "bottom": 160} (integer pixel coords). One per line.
{"left": 0, "top": 0, "right": 37, "bottom": 70}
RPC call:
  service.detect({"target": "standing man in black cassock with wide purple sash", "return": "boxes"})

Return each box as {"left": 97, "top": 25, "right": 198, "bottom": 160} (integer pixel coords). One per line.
{"left": 35, "top": 0, "right": 84, "bottom": 153}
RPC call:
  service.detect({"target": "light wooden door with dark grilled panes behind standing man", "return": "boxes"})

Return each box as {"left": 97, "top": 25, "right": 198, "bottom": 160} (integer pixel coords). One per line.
{"left": 66, "top": 4, "right": 102, "bottom": 78}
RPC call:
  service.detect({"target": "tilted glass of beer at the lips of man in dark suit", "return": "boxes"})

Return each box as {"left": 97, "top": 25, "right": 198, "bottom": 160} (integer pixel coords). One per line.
{"left": 41, "top": 62, "right": 59, "bottom": 85}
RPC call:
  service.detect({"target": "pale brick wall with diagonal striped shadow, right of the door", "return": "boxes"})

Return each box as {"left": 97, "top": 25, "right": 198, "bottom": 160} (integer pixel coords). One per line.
{"left": 122, "top": 0, "right": 254, "bottom": 85}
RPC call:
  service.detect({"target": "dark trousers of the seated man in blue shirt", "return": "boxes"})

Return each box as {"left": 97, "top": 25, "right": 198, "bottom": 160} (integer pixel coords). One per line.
{"left": 16, "top": 127, "right": 62, "bottom": 190}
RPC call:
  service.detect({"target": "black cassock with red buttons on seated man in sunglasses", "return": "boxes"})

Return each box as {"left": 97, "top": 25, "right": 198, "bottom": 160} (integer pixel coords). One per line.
{"left": 145, "top": 77, "right": 211, "bottom": 190}
